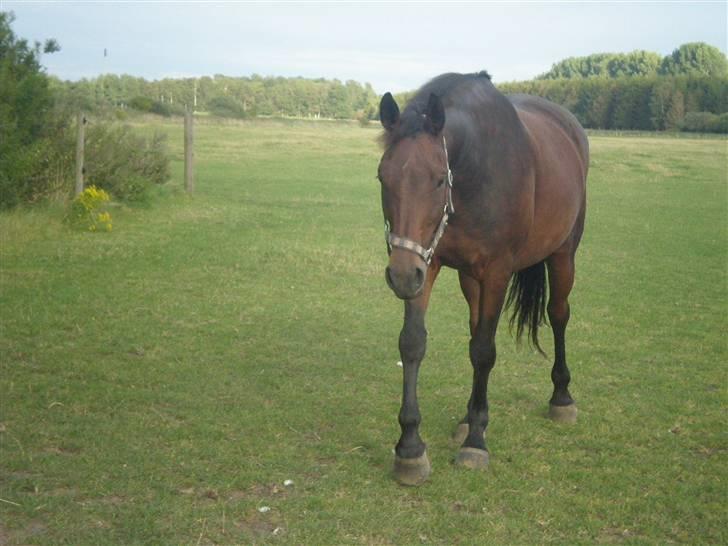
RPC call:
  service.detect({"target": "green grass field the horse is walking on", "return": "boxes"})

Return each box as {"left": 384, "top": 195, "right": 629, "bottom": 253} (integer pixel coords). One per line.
{"left": 0, "top": 117, "right": 728, "bottom": 545}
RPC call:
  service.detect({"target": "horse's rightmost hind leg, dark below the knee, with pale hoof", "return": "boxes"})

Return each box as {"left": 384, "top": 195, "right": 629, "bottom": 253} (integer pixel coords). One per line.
{"left": 546, "top": 251, "right": 576, "bottom": 423}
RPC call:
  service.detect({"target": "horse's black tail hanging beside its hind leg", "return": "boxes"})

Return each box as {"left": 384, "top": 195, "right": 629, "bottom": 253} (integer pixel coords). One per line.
{"left": 506, "top": 262, "right": 546, "bottom": 356}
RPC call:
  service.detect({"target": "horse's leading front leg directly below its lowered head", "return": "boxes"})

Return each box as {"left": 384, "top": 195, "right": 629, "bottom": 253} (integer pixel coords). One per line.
{"left": 394, "top": 263, "right": 440, "bottom": 485}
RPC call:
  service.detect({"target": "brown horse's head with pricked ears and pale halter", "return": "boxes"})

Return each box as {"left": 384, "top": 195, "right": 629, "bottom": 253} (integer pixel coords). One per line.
{"left": 378, "top": 93, "right": 452, "bottom": 299}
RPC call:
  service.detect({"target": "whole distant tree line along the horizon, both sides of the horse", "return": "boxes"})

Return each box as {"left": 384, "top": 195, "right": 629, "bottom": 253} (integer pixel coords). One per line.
{"left": 57, "top": 43, "right": 728, "bottom": 133}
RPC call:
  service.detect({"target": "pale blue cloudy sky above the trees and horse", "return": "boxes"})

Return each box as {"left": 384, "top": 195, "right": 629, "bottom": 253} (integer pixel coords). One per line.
{"left": 0, "top": 0, "right": 728, "bottom": 93}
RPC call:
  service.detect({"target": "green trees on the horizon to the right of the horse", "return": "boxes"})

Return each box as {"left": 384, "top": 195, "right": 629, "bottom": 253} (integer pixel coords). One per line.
{"left": 506, "top": 42, "right": 728, "bottom": 133}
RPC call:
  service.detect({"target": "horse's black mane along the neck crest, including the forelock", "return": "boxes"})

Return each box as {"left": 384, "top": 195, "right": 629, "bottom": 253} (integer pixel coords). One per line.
{"left": 384, "top": 70, "right": 490, "bottom": 147}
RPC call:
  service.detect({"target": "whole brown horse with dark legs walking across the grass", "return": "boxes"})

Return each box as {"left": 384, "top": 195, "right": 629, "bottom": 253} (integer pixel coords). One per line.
{"left": 379, "top": 72, "right": 589, "bottom": 485}
